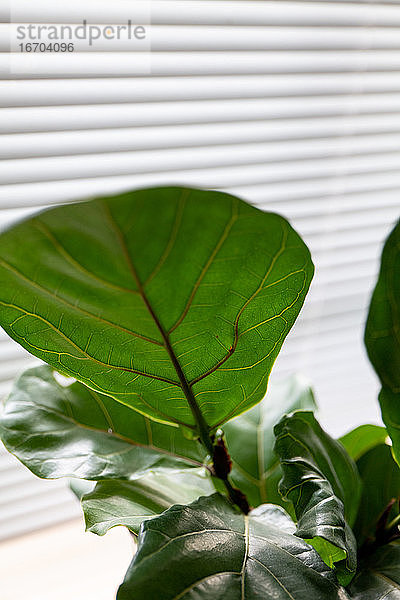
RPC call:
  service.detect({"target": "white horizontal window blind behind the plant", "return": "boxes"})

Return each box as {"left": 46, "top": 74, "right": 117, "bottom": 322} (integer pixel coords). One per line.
{"left": 0, "top": 0, "right": 400, "bottom": 538}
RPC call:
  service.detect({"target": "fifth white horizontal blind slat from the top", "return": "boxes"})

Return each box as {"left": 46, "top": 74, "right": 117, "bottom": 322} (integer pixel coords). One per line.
{"left": 0, "top": 91, "right": 400, "bottom": 133}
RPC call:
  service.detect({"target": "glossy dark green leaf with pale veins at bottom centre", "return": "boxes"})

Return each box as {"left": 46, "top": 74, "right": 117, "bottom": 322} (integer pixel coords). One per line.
{"left": 118, "top": 495, "right": 347, "bottom": 600}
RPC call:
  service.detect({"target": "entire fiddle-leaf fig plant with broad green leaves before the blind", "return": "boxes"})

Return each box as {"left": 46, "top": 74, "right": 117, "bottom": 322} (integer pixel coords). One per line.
{"left": 0, "top": 188, "right": 400, "bottom": 600}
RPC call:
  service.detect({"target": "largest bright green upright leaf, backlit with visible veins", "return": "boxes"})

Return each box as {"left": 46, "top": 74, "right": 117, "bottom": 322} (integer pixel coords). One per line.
{"left": 0, "top": 188, "right": 313, "bottom": 432}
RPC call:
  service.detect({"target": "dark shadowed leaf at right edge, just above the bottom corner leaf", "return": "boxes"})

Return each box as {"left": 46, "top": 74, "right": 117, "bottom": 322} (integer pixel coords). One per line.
{"left": 354, "top": 444, "right": 400, "bottom": 546}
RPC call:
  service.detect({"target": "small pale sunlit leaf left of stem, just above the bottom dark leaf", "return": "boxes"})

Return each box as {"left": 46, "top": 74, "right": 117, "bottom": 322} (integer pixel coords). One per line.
{"left": 81, "top": 469, "right": 215, "bottom": 535}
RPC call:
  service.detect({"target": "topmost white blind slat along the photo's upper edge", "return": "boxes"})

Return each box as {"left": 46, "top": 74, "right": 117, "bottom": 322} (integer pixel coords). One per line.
{"left": 4, "top": 0, "right": 400, "bottom": 26}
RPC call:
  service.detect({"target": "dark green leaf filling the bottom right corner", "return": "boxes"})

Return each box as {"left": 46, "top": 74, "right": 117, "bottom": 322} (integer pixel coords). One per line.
{"left": 349, "top": 542, "right": 400, "bottom": 600}
